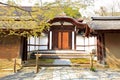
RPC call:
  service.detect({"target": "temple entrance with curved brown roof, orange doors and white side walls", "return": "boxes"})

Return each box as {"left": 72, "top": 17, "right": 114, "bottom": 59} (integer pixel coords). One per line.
{"left": 28, "top": 16, "right": 96, "bottom": 53}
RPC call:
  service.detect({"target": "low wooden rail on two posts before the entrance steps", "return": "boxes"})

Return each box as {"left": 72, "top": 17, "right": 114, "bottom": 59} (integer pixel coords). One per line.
{"left": 35, "top": 53, "right": 94, "bottom": 73}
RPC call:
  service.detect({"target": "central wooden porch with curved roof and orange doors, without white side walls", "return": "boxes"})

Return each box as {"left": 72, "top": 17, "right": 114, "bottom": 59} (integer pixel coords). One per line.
{"left": 48, "top": 16, "right": 89, "bottom": 50}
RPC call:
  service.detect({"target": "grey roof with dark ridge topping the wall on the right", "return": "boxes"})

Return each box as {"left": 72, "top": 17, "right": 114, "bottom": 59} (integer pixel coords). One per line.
{"left": 88, "top": 17, "right": 120, "bottom": 30}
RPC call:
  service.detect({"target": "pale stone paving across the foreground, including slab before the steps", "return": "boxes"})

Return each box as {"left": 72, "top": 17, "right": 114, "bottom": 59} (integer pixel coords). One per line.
{"left": 0, "top": 59, "right": 120, "bottom": 80}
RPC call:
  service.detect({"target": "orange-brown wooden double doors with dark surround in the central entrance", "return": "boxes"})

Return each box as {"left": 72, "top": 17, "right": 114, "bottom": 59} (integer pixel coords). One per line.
{"left": 52, "top": 30, "right": 72, "bottom": 50}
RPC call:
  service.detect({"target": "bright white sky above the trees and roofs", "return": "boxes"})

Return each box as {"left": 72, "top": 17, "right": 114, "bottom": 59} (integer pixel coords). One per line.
{"left": 0, "top": 0, "right": 120, "bottom": 17}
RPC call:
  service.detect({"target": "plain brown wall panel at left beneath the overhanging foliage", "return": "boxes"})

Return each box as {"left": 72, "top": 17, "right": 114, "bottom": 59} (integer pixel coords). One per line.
{"left": 0, "top": 36, "right": 21, "bottom": 59}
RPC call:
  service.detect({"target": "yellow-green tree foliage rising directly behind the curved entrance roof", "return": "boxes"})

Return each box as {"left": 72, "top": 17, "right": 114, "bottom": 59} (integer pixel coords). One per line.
{"left": 46, "top": 1, "right": 83, "bottom": 18}
